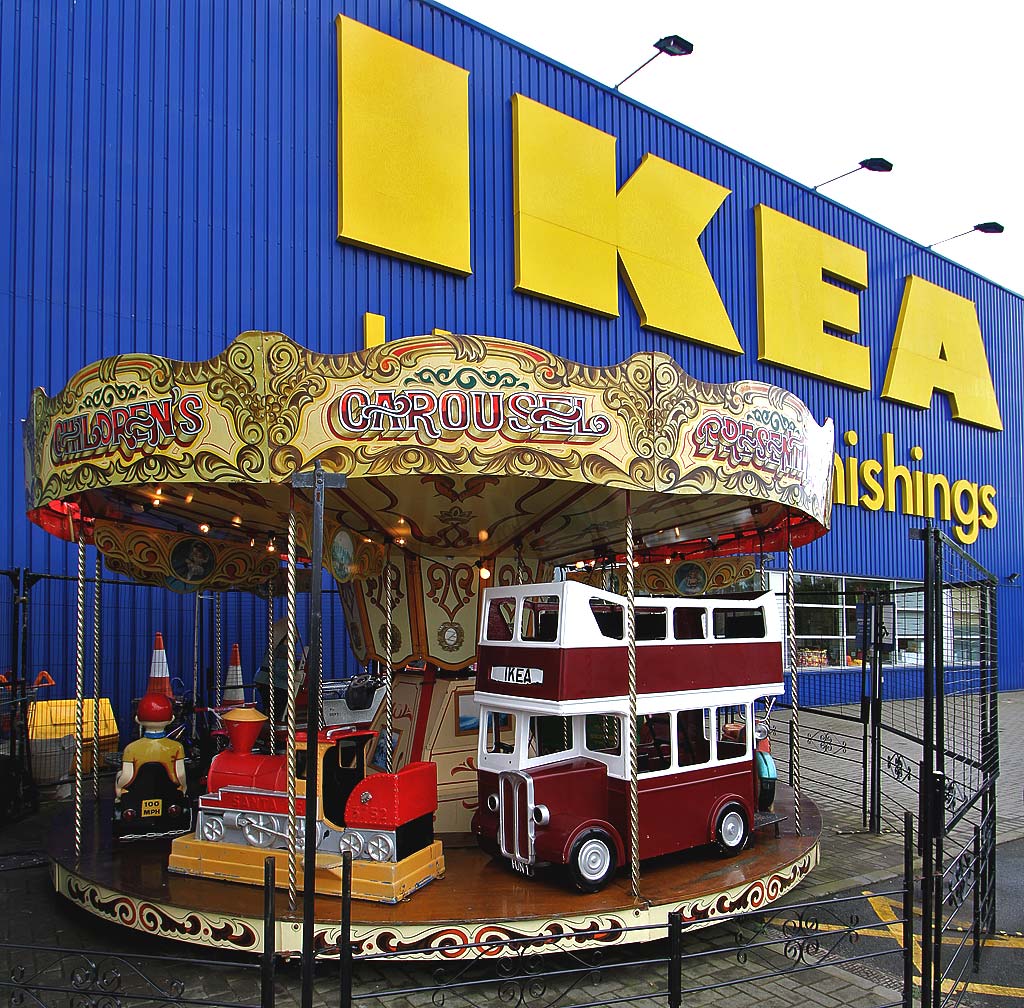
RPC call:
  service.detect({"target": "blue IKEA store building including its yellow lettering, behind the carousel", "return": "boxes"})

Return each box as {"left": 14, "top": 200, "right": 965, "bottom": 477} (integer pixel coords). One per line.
{"left": 0, "top": 0, "right": 1024, "bottom": 722}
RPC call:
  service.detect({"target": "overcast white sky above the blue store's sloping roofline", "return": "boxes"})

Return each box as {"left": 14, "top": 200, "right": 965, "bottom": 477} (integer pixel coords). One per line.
{"left": 441, "top": 0, "right": 1024, "bottom": 293}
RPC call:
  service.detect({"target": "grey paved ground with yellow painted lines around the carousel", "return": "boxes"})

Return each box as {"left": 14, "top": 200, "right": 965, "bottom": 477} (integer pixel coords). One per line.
{"left": 0, "top": 692, "right": 1024, "bottom": 1008}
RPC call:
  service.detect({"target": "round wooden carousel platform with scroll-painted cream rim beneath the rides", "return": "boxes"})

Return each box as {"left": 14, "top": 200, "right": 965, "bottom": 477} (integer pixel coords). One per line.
{"left": 50, "top": 785, "right": 821, "bottom": 959}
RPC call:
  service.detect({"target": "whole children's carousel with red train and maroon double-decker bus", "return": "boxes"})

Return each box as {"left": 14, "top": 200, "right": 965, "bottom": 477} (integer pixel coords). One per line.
{"left": 27, "top": 332, "right": 833, "bottom": 958}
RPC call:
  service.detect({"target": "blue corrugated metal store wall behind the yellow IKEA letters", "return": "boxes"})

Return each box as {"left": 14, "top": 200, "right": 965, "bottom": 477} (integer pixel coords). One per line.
{"left": 0, "top": 0, "right": 1024, "bottom": 717}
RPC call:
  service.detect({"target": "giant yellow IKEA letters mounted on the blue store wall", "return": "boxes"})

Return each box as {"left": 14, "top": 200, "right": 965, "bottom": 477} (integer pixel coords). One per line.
{"left": 336, "top": 15, "right": 1002, "bottom": 430}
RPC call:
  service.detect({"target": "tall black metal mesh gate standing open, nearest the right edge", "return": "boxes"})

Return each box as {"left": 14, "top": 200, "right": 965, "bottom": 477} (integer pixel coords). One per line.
{"left": 919, "top": 529, "right": 999, "bottom": 1008}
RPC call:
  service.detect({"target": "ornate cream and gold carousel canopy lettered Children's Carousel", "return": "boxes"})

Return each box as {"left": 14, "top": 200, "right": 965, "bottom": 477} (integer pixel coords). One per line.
{"left": 26, "top": 332, "right": 833, "bottom": 667}
